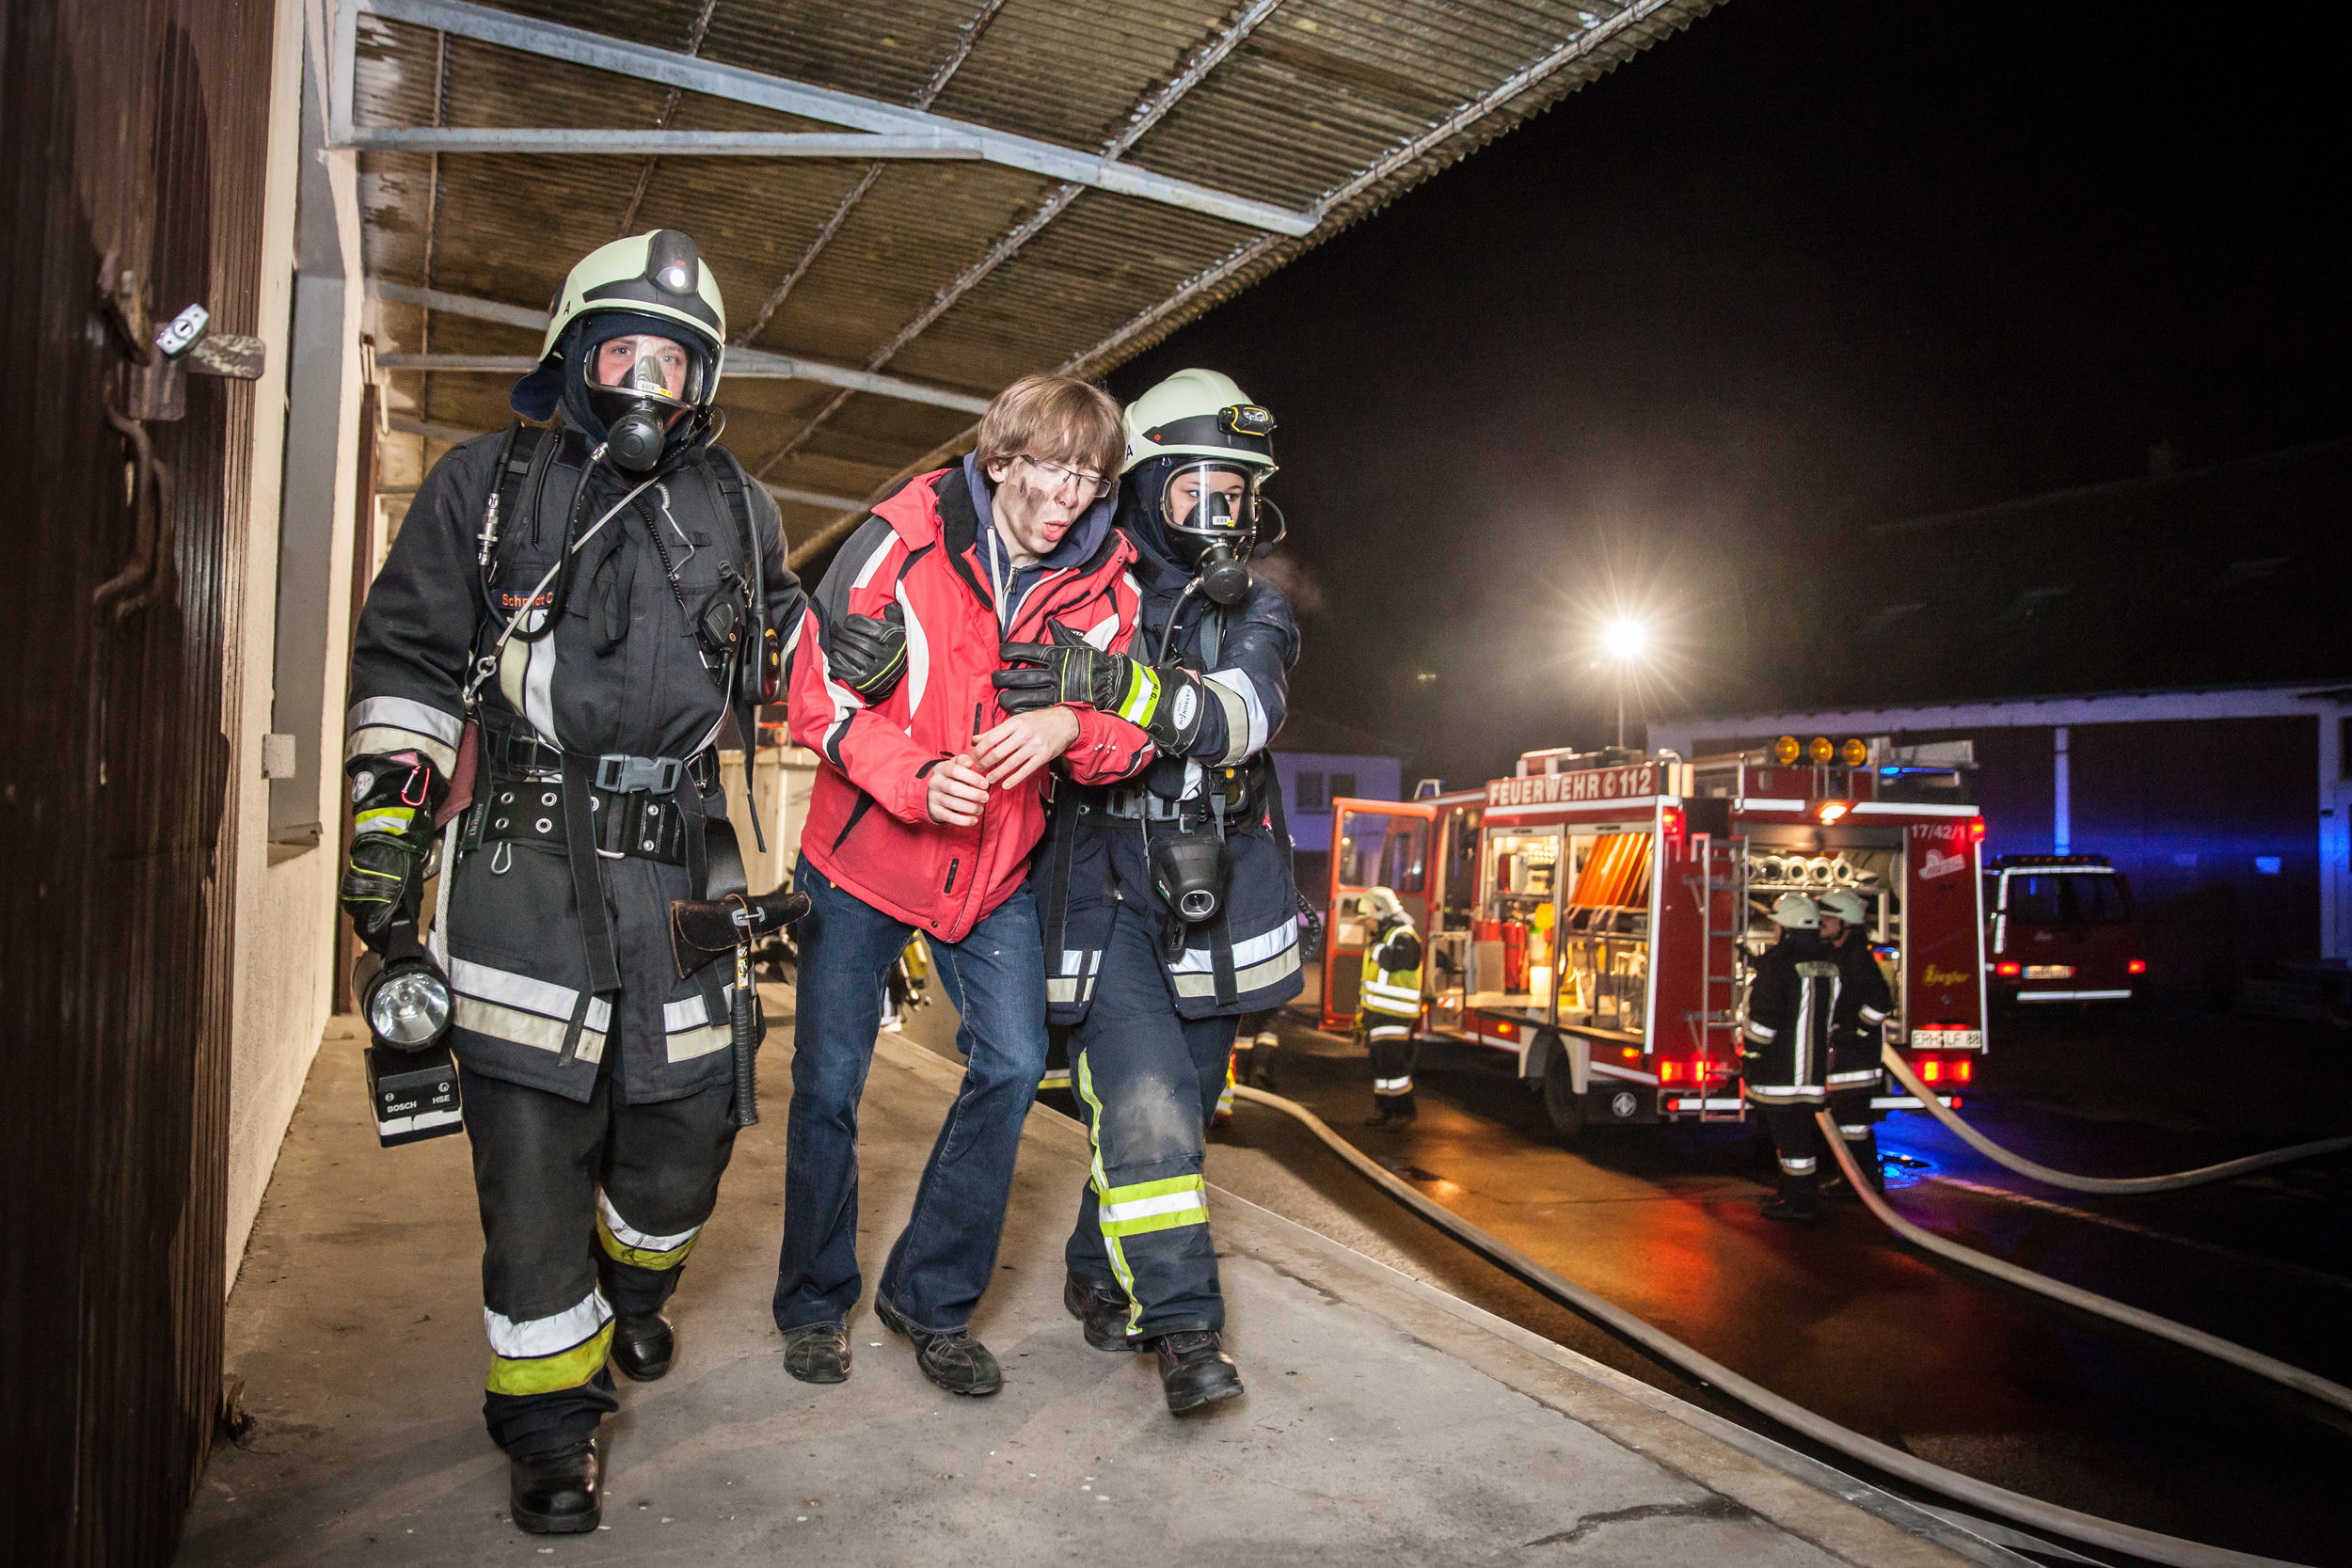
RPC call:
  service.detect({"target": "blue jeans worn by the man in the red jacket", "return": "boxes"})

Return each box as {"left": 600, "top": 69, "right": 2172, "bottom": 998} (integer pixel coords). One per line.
{"left": 776, "top": 858, "right": 1047, "bottom": 1333}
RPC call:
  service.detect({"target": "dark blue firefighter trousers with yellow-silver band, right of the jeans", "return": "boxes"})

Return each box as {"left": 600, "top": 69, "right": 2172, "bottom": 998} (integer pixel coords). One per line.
{"left": 1063, "top": 903, "right": 1240, "bottom": 1338}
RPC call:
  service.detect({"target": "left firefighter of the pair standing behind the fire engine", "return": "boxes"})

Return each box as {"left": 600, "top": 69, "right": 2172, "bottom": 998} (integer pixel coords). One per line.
{"left": 1740, "top": 894, "right": 1839, "bottom": 1220}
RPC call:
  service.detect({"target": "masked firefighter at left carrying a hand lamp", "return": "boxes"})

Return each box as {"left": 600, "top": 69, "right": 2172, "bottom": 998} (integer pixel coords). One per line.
{"left": 343, "top": 230, "right": 870, "bottom": 1533}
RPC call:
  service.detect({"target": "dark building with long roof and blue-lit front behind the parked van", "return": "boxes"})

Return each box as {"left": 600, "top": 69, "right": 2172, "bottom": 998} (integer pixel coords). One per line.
{"left": 1649, "top": 439, "right": 2352, "bottom": 1002}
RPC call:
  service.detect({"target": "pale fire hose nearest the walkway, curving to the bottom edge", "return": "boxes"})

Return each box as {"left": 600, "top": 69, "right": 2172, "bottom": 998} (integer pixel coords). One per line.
{"left": 1232, "top": 1086, "right": 2305, "bottom": 1568}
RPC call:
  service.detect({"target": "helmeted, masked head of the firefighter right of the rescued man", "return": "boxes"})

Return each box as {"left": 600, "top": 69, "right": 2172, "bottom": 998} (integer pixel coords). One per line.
{"left": 1122, "top": 369, "right": 1287, "bottom": 609}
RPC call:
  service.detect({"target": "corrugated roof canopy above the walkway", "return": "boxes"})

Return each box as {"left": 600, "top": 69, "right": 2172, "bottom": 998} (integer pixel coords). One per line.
{"left": 353, "top": 0, "right": 1717, "bottom": 547}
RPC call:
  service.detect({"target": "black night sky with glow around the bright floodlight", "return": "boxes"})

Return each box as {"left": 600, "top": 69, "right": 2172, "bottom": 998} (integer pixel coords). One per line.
{"left": 1113, "top": 0, "right": 2352, "bottom": 785}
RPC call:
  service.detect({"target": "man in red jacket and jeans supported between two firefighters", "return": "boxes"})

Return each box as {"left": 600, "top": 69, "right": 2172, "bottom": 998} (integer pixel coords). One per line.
{"left": 774, "top": 376, "right": 1152, "bottom": 1394}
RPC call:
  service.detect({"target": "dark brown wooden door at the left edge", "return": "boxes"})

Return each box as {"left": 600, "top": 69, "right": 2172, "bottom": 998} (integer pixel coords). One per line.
{"left": 0, "top": 0, "right": 282, "bottom": 1563}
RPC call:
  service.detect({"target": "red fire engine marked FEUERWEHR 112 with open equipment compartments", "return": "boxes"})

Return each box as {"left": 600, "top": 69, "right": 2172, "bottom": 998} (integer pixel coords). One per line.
{"left": 1322, "top": 736, "right": 1988, "bottom": 1143}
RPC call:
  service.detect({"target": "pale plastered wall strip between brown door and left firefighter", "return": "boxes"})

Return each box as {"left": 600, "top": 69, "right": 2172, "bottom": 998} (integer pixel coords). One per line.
{"left": 224, "top": 0, "right": 360, "bottom": 1286}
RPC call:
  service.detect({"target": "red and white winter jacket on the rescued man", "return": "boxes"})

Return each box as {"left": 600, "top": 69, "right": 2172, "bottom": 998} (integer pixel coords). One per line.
{"left": 790, "top": 466, "right": 1152, "bottom": 942}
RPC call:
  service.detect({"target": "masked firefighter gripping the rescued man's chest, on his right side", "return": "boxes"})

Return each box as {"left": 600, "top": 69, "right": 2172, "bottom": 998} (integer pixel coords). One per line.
{"left": 995, "top": 369, "right": 1301, "bottom": 1413}
